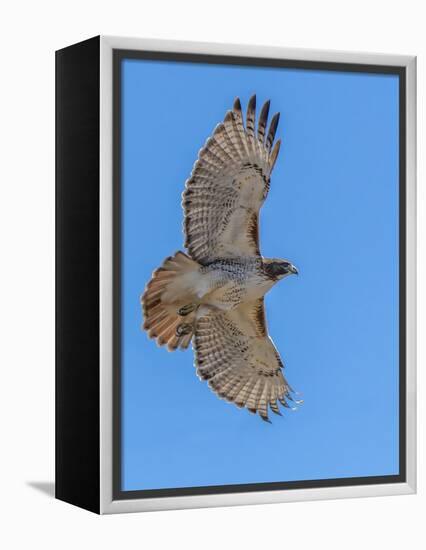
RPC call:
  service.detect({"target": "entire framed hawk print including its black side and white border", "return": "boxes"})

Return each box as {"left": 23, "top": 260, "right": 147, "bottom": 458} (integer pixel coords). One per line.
{"left": 56, "top": 37, "right": 416, "bottom": 513}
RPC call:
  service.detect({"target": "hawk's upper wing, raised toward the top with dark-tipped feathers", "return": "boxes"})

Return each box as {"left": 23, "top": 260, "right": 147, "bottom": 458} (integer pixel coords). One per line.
{"left": 182, "top": 96, "right": 280, "bottom": 263}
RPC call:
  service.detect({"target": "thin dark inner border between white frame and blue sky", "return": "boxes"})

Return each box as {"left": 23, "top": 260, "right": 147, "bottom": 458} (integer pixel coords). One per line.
{"left": 113, "top": 49, "right": 407, "bottom": 500}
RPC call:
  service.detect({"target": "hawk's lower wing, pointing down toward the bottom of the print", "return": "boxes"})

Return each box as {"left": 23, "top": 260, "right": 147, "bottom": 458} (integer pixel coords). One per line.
{"left": 193, "top": 298, "right": 292, "bottom": 420}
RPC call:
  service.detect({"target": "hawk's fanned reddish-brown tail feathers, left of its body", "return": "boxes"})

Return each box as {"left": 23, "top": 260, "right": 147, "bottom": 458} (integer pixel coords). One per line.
{"left": 141, "top": 252, "right": 200, "bottom": 351}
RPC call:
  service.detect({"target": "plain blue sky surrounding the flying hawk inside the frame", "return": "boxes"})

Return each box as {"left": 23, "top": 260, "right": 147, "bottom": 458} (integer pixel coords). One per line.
{"left": 122, "top": 60, "right": 398, "bottom": 490}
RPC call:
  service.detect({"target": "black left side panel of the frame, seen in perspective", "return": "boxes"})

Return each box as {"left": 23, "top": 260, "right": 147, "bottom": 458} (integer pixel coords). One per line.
{"left": 55, "top": 37, "right": 100, "bottom": 513}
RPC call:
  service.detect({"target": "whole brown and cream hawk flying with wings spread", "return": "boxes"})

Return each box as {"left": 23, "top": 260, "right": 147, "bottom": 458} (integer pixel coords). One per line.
{"left": 141, "top": 96, "right": 298, "bottom": 421}
